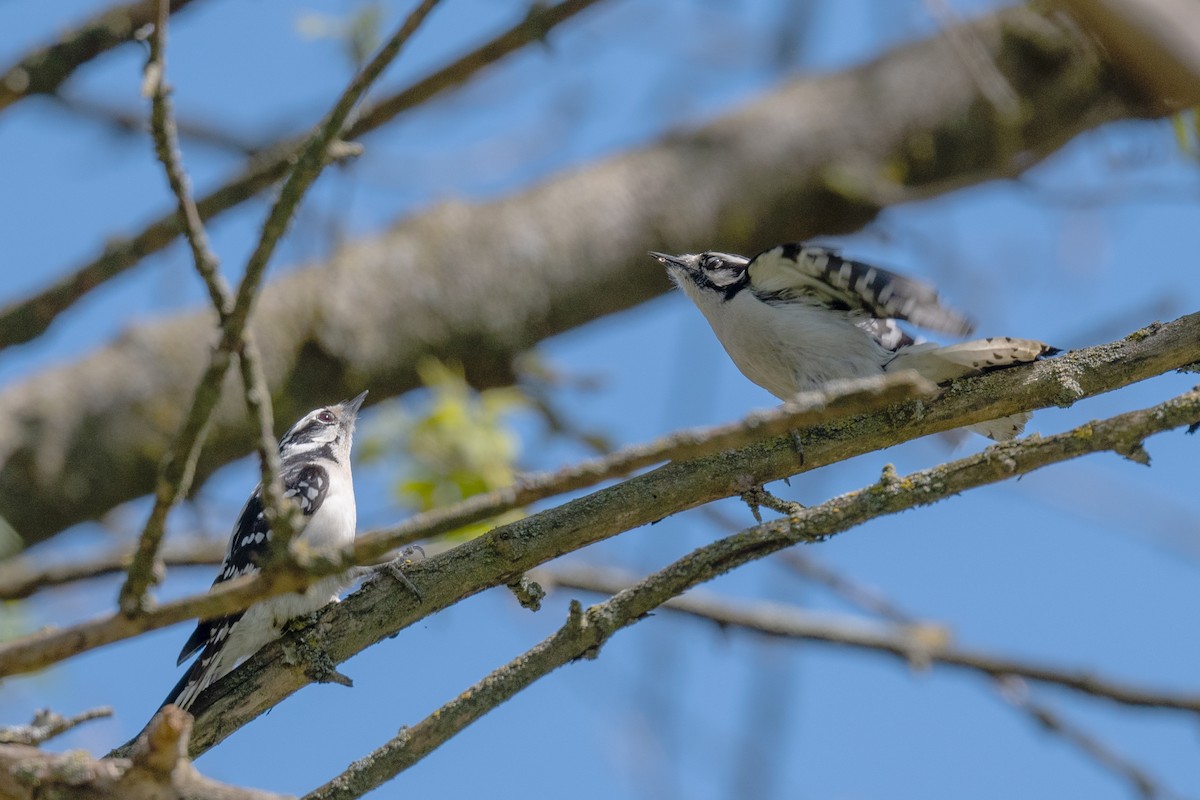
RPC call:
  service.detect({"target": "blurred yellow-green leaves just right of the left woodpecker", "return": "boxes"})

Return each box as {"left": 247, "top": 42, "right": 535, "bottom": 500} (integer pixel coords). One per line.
{"left": 362, "top": 359, "right": 529, "bottom": 539}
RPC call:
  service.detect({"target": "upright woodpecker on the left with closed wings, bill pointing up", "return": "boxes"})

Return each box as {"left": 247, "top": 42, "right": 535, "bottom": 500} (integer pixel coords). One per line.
{"left": 163, "top": 392, "right": 367, "bottom": 710}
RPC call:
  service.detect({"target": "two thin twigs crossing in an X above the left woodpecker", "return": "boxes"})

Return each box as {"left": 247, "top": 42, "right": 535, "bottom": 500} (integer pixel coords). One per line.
{"left": 120, "top": 0, "right": 438, "bottom": 614}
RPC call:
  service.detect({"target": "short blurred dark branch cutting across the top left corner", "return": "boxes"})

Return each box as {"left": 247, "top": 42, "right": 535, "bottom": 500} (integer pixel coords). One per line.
{"left": 0, "top": 0, "right": 200, "bottom": 112}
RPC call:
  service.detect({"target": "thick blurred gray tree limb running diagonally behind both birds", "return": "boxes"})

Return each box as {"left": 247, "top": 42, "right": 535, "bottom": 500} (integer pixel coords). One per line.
{"left": 0, "top": 8, "right": 1151, "bottom": 545}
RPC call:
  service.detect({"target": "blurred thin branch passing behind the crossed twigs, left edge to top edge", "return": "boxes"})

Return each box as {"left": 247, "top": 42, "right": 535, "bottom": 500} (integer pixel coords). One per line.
{"left": 0, "top": 0, "right": 599, "bottom": 348}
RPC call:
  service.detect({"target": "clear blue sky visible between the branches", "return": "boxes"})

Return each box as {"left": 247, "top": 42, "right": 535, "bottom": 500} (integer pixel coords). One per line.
{"left": 0, "top": 0, "right": 1200, "bottom": 799}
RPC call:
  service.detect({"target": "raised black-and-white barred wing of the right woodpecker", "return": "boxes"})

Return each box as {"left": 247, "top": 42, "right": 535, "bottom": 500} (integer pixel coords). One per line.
{"left": 746, "top": 242, "right": 974, "bottom": 335}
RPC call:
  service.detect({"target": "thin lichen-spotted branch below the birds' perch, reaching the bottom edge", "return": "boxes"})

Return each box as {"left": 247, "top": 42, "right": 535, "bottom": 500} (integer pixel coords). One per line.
{"left": 304, "top": 389, "right": 1200, "bottom": 800}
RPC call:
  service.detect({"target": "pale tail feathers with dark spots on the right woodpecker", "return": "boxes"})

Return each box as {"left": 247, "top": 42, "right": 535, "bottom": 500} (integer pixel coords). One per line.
{"left": 887, "top": 336, "right": 1058, "bottom": 441}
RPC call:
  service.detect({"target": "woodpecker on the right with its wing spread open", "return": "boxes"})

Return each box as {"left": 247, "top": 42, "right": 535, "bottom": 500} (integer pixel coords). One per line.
{"left": 650, "top": 242, "right": 1058, "bottom": 440}
